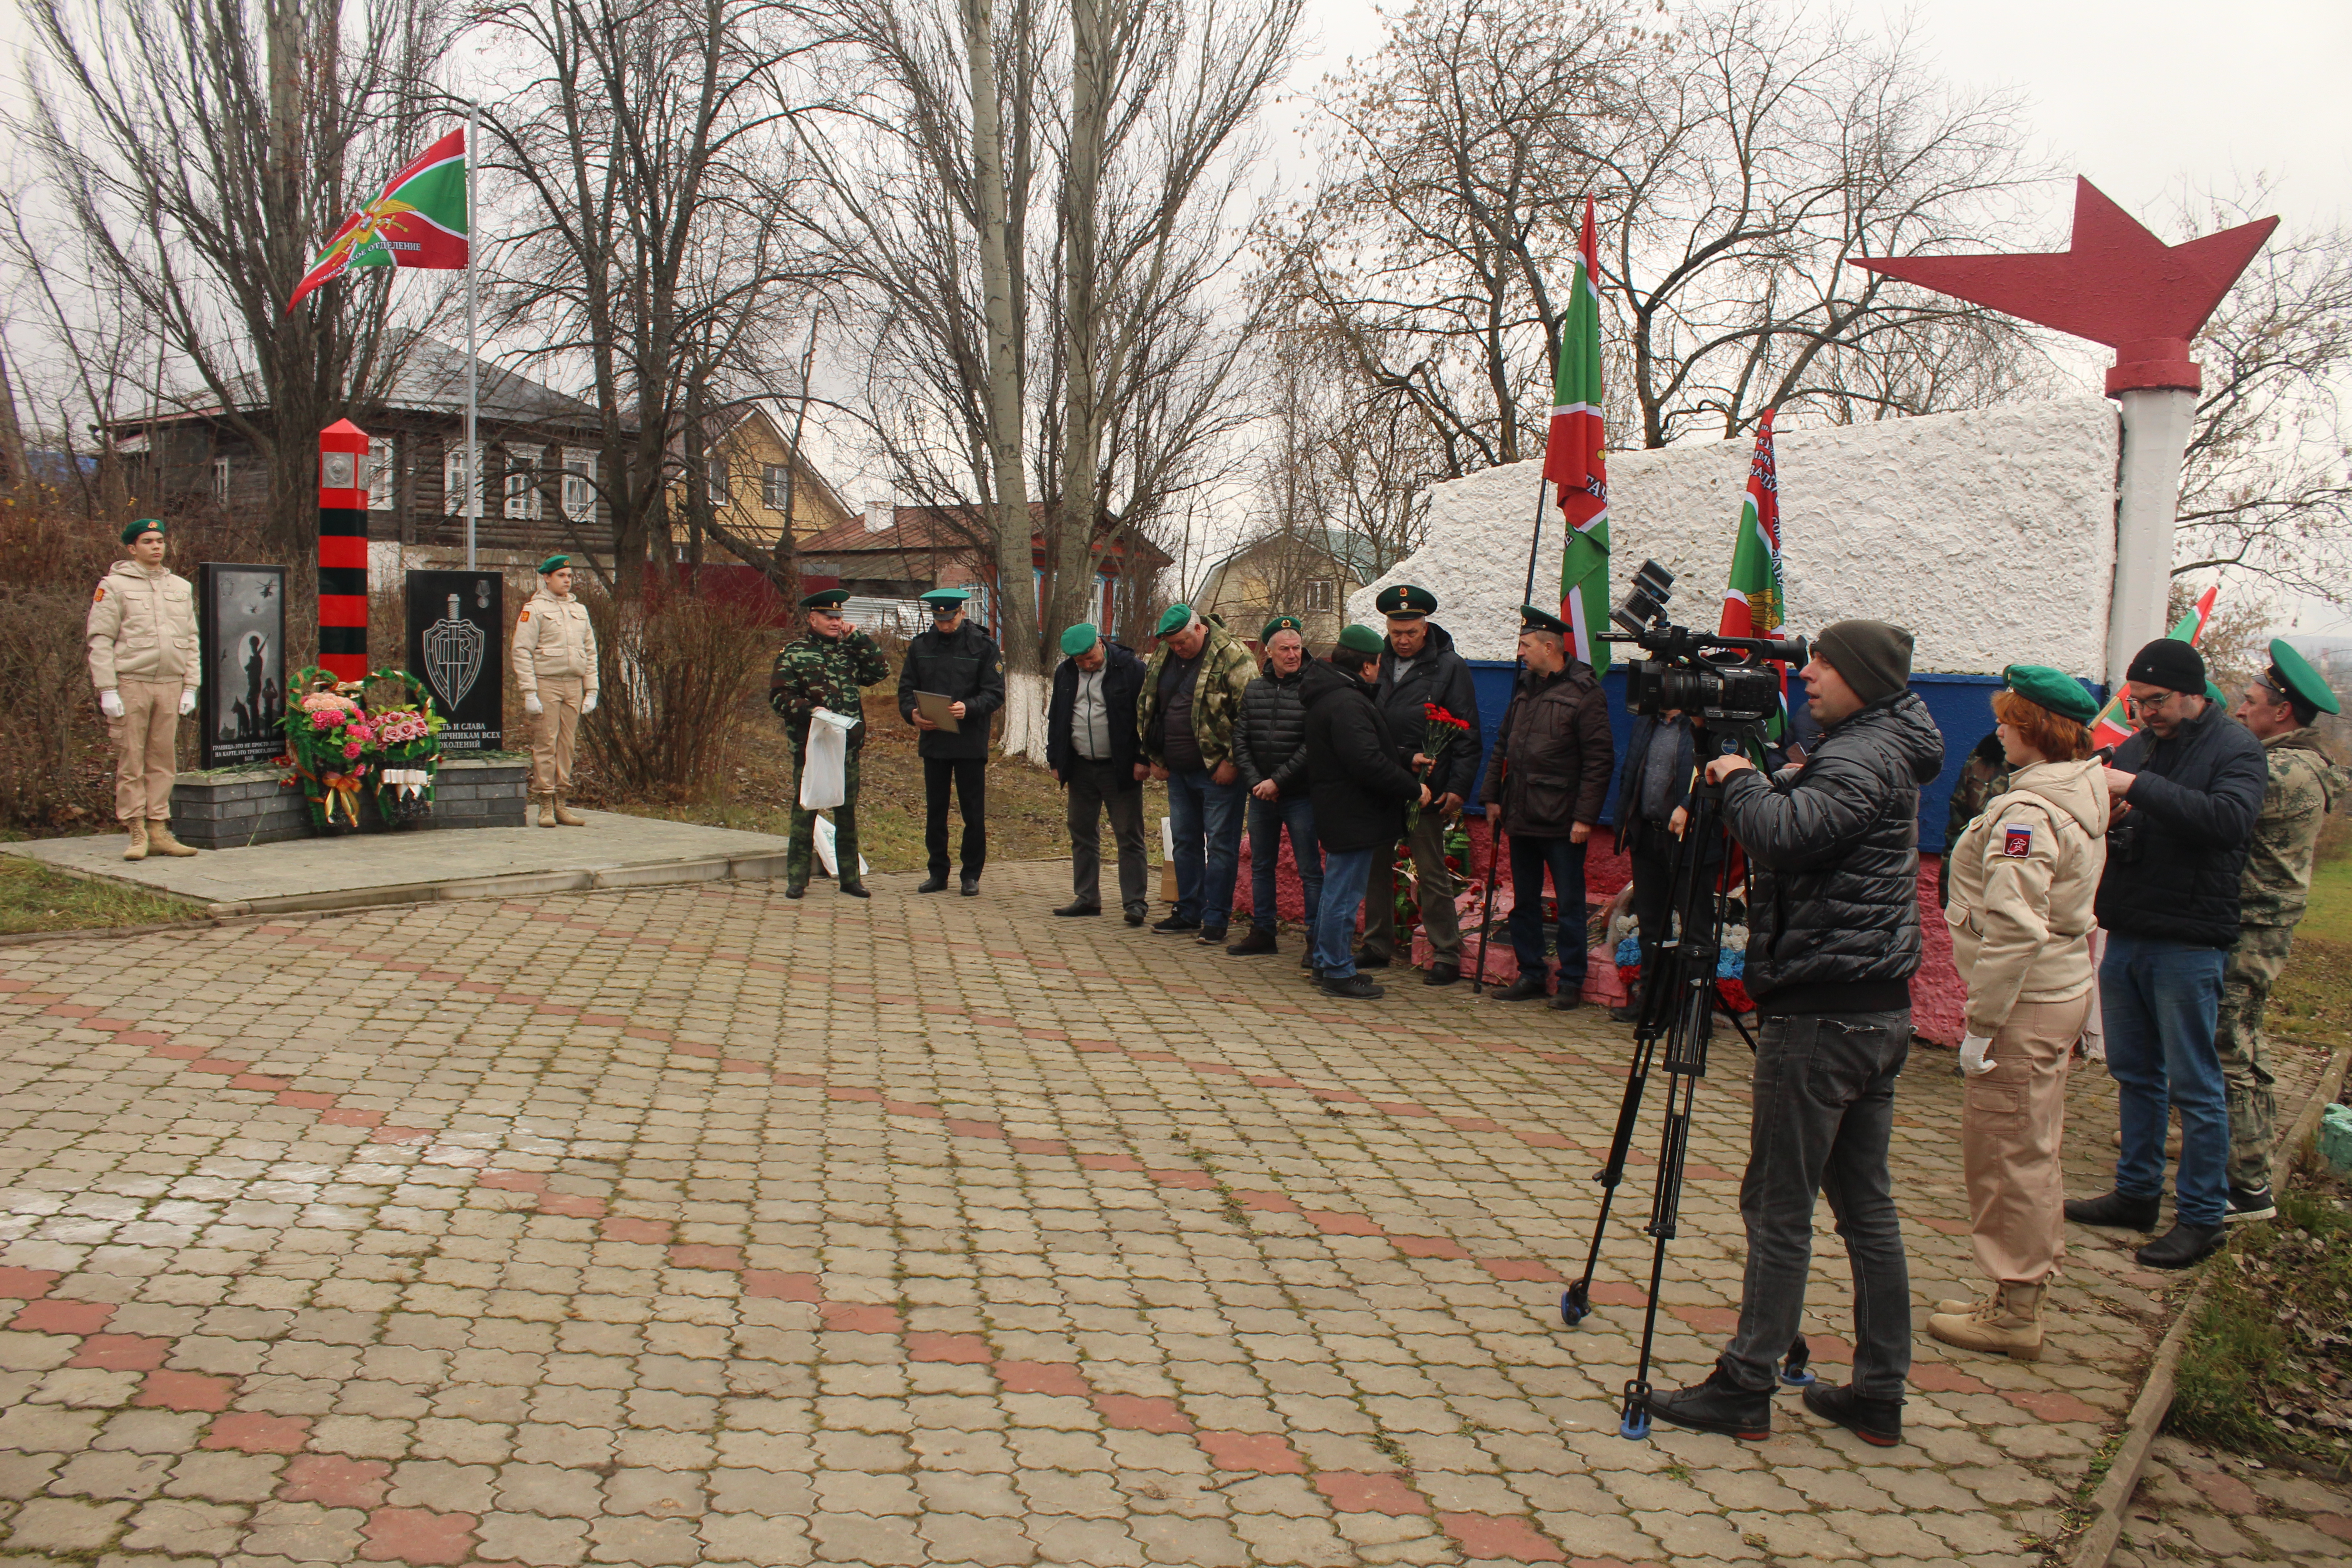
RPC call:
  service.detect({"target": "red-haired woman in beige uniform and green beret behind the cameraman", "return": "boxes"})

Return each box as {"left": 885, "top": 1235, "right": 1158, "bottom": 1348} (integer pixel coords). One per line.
{"left": 1926, "top": 665, "right": 2107, "bottom": 1361}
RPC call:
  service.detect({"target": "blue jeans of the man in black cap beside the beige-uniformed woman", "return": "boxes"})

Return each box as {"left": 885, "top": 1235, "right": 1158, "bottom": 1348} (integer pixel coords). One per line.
{"left": 2098, "top": 931, "right": 2230, "bottom": 1225}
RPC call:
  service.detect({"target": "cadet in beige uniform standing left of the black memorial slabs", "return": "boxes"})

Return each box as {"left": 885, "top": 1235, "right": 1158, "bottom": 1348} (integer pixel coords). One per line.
{"left": 82, "top": 517, "right": 200, "bottom": 860}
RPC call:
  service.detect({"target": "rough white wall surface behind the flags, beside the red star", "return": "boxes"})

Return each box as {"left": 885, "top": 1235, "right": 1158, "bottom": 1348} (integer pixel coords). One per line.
{"left": 1348, "top": 397, "right": 2117, "bottom": 679}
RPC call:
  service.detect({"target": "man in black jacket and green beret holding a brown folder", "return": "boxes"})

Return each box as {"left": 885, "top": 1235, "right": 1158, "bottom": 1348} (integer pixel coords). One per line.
{"left": 898, "top": 588, "right": 1004, "bottom": 898}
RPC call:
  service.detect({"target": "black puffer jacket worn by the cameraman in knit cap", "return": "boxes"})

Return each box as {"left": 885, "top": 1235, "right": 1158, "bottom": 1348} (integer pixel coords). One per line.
{"left": 1724, "top": 691, "right": 1943, "bottom": 1013}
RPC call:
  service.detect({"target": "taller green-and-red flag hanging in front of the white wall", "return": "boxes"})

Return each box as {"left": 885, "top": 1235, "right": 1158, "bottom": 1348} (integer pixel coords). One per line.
{"left": 1543, "top": 195, "right": 1609, "bottom": 675}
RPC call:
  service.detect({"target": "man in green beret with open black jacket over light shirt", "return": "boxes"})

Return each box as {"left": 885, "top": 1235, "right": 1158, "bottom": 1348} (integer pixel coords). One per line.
{"left": 1044, "top": 623, "right": 1150, "bottom": 926}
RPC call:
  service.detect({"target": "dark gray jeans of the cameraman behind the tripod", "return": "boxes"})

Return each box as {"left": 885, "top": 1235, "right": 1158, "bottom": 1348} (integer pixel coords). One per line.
{"left": 1720, "top": 1009, "right": 1910, "bottom": 1399}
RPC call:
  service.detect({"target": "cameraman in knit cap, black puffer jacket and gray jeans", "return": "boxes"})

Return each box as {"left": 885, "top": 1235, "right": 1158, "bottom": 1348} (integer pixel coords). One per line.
{"left": 1649, "top": 621, "right": 1943, "bottom": 1446}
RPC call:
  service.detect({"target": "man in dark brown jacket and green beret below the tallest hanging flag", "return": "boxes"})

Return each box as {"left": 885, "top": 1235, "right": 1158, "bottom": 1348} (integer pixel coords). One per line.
{"left": 1480, "top": 604, "right": 1616, "bottom": 1011}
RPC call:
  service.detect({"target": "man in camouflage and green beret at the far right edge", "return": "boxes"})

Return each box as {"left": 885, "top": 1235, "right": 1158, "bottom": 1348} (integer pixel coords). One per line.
{"left": 2213, "top": 637, "right": 2352, "bottom": 1225}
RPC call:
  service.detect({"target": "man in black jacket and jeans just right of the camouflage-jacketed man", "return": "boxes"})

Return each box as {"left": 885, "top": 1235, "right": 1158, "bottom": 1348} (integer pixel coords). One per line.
{"left": 1225, "top": 616, "right": 1322, "bottom": 966}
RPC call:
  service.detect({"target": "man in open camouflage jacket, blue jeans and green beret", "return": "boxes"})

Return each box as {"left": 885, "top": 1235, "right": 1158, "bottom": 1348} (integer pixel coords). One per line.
{"left": 1136, "top": 604, "right": 1256, "bottom": 947}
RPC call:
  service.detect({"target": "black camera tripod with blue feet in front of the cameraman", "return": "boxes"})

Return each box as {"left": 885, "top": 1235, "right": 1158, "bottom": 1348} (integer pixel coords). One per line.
{"left": 1559, "top": 720, "right": 1813, "bottom": 1441}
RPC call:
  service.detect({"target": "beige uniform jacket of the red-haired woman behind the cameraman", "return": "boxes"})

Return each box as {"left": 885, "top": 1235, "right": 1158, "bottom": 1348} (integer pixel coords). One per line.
{"left": 1943, "top": 762, "right": 2107, "bottom": 1039}
